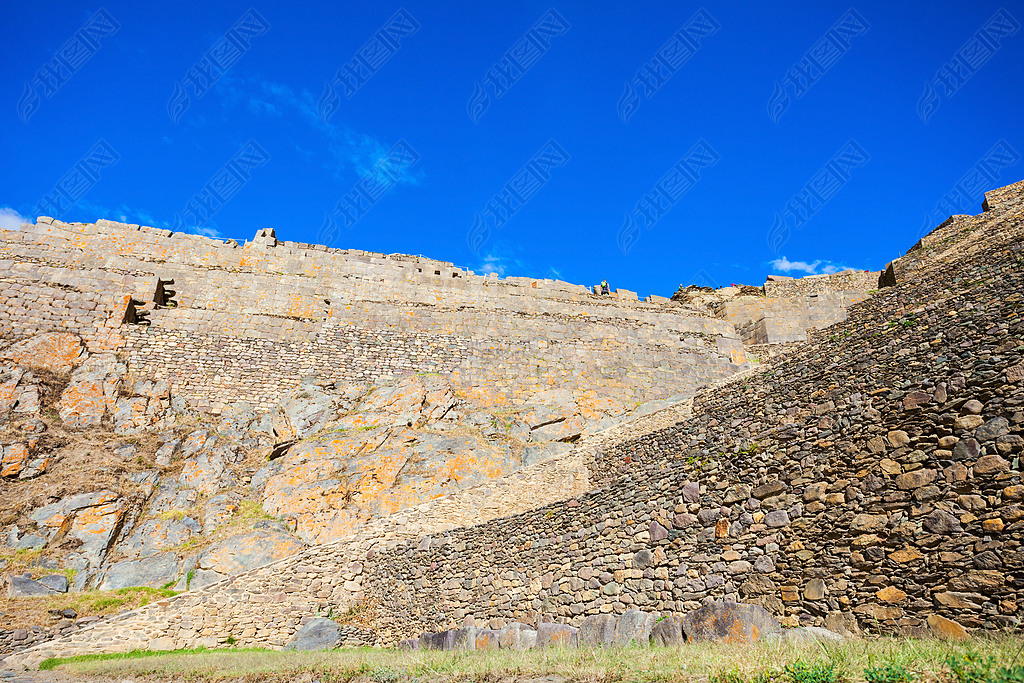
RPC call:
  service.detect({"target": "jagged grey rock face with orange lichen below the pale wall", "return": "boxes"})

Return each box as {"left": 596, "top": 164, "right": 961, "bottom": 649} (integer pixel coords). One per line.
{"left": 0, "top": 333, "right": 626, "bottom": 602}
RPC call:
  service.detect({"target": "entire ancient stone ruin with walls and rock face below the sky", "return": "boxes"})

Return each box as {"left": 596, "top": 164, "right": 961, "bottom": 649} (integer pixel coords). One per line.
{"left": 0, "top": 182, "right": 1024, "bottom": 667}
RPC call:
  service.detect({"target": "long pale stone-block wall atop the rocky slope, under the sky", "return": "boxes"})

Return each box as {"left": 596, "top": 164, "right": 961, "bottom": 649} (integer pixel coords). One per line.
{"left": 0, "top": 217, "right": 744, "bottom": 413}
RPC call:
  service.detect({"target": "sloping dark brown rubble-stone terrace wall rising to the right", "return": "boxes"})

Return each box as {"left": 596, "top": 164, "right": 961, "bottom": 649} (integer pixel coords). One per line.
{"left": 6, "top": 183, "right": 1024, "bottom": 663}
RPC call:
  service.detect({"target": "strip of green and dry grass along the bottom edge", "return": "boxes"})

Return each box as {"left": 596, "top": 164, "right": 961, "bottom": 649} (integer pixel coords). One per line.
{"left": 39, "top": 636, "right": 1024, "bottom": 683}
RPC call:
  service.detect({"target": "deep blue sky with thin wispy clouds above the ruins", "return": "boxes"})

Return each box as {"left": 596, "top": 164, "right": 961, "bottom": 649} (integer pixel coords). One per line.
{"left": 0, "top": 0, "right": 1024, "bottom": 295}
